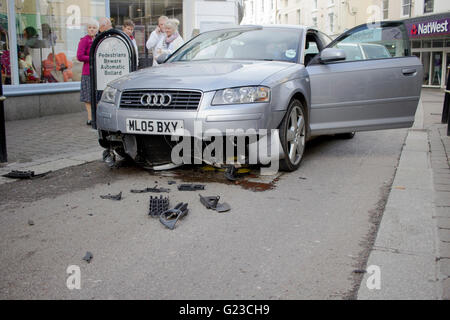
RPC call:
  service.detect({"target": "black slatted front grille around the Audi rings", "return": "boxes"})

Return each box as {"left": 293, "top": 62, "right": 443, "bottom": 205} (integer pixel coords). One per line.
{"left": 120, "top": 90, "right": 202, "bottom": 110}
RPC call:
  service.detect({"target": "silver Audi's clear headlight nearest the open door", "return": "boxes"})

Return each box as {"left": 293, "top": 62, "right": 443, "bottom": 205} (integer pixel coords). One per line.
{"left": 212, "top": 87, "right": 270, "bottom": 105}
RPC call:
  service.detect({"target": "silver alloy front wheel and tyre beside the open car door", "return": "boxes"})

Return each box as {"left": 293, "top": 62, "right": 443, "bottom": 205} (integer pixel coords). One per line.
{"left": 280, "top": 99, "right": 308, "bottom": 172}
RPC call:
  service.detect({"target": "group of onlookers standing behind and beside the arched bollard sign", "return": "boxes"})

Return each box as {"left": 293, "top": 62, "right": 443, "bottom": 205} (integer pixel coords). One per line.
{"left": 77, "top": 16, "right": 184, "bottom": 125}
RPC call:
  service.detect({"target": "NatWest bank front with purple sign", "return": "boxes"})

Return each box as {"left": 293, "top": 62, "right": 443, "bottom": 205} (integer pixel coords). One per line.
{"left": 406, "top": 13, "right": 450, "bottom": 88}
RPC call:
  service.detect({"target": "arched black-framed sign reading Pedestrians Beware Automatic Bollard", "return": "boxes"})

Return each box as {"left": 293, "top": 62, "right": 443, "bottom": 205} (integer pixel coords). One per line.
{"left": 89, "top": 29, "right": 137, "bottom": 129}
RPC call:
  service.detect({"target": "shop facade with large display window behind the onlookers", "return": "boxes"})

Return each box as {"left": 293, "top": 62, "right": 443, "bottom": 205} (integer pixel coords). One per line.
{"left": 0, "top": 0, "right": 242, "bottom": 120}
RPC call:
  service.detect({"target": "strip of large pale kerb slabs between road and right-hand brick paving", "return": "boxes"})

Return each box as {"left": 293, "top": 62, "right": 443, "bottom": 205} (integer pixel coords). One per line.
{"left": 357, "top": 103, "right": 442, "bottom": 300}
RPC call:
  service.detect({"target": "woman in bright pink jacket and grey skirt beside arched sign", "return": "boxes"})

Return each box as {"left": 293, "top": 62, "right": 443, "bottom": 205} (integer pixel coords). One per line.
{"left": 77, "top": 20, "right": 99, "bottom": 125}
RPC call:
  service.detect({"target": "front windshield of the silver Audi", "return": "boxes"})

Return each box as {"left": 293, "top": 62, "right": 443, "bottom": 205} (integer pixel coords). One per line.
{"left": 168, "top": 28, "right": 301, "bottom": 62}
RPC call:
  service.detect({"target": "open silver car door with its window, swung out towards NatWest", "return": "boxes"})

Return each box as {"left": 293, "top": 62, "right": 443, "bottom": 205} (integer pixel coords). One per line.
{"left": 306, "top": 22, "right": 423, "bottom": 135}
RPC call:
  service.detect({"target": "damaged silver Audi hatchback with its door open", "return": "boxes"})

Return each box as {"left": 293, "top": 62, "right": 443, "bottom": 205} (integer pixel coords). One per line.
{"left": 97, "top": 22, "right": 423, "bottom": 171}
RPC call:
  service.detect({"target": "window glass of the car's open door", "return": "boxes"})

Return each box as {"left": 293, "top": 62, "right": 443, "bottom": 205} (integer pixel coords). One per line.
{"left": 330, "top": 23, "right": 410, "bottom": 61}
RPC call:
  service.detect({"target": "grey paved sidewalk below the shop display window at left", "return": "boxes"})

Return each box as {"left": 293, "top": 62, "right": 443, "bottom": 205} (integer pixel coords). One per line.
{"left": 0, "top": 112, "right": 102, "bottom": 184}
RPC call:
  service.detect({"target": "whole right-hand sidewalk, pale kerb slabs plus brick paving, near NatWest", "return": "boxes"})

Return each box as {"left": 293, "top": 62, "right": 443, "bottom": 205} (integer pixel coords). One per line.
{"left": 358, "top": 89, "right": 450, "bottom": 300}
